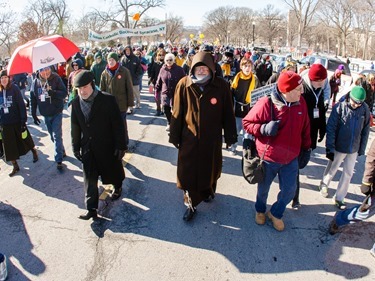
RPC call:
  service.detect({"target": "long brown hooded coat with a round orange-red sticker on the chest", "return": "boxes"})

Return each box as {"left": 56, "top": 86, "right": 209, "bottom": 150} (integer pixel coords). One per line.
{"left": 169, "top": 52, "right": 237, "bottom": 206}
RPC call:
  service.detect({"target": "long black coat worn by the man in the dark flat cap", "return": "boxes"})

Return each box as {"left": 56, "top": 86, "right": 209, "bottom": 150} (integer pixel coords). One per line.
{"left": 71, "top": 92, "right": 127, "bottom": 184}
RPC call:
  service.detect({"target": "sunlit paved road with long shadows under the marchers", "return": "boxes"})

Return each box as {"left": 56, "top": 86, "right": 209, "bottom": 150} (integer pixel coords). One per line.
{"left": 0, "top": 86, "right": 375, "bottom": 281}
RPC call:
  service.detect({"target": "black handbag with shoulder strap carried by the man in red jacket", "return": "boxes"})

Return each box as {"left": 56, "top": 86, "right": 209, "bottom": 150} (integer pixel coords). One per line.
{"left": 241, "top": 96, "right": 273, "bottom": 184}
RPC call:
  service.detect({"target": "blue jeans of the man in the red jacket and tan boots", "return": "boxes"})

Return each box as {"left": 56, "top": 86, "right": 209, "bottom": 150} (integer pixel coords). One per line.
{"left": 255, "top": 158, "right": 298, "bottom": 219}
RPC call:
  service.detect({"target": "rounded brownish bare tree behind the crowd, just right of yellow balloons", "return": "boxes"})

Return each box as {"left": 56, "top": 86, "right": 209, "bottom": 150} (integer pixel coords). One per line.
{"left": 203, "top": 6, "right": 235, "bottom": 44}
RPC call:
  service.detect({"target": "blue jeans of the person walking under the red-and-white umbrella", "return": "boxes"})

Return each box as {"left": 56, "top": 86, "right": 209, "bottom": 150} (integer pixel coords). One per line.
{"left": 44, "top": 113, "right": 65, "bottom": 162}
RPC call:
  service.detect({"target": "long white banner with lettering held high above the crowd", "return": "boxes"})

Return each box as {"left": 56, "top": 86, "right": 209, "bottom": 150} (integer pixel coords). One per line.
{"left": 88, "top": 24, "right": 167, "bottom": 42}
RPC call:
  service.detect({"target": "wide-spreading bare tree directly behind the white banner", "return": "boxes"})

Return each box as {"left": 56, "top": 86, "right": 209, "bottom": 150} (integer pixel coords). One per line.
{"left": 95, "top": 0, "right": 165, "bottom": 44}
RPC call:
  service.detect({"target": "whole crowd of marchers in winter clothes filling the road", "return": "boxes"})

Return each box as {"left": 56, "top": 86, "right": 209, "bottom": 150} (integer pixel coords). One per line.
{"left": 0, "top": 43, "right": 375, "bottom": 264}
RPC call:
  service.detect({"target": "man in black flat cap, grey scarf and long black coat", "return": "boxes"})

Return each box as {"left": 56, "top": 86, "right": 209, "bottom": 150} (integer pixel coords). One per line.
{"left": 71, "top": 70, "right": 128, "bottom": 220}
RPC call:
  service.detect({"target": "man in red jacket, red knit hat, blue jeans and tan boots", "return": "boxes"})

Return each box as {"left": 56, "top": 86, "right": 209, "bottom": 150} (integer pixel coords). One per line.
{"left": 242, "top": 71, "right": 311, "bottom": 231}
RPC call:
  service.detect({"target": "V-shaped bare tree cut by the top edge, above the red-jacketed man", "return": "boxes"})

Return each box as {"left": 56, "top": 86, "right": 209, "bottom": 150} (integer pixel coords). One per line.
{"left": 284, "top": 0, "right": 321, "bottom": 48}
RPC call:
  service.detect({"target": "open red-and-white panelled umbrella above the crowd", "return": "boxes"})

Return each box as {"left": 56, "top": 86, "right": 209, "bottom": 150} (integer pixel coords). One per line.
{"left": 7, "top": 35, "right": 79, "bottom": 75}
